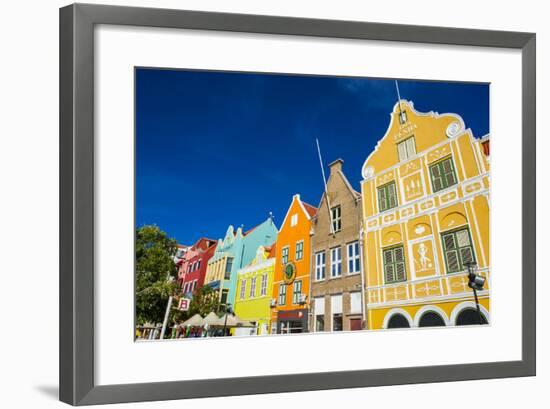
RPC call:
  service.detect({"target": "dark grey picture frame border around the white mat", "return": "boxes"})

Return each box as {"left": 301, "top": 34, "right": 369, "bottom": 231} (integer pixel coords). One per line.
{"left": 59, "top": 4, "right": 536, "bottom": 405}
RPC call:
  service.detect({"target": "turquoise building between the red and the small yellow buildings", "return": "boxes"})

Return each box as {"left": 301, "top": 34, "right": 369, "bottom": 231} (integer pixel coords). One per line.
{"left": 204, "top": 216, "right": 277, "bottom": 305}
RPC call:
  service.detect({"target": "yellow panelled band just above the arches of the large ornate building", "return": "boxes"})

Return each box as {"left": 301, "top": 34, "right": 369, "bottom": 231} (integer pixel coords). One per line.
{"left": 367, "top": 268, "right": 490, "bottom": 306}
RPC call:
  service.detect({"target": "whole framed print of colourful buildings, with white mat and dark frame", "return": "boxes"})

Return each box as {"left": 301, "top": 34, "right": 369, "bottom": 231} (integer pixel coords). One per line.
{"left": 60, "top": 4, "right": 536, "bottom": 405}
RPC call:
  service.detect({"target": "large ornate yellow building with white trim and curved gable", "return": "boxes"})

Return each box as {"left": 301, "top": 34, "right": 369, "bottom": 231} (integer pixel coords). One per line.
{"left": 361, "top": 100, "right": 490, "bottom": 329}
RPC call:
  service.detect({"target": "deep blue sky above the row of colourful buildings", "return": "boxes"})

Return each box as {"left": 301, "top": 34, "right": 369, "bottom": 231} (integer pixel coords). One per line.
{"left": 136, "top": 68, "right": 489, "bottom": 244}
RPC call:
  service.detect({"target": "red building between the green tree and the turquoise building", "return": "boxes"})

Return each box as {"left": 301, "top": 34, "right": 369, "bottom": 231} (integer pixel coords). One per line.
{"left": 178, "top": 237, "right": 217, "bottom": 297}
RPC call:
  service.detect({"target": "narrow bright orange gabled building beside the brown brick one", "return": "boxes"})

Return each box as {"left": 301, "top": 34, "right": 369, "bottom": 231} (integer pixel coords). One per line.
{"left": 271, "top": 195, "right": 317, "bottom": 334}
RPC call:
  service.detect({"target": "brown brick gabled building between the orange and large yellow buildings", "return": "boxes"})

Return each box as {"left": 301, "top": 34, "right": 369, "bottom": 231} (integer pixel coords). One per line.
{"left": 310, "top": 159, "right": 366, "bottom": 332}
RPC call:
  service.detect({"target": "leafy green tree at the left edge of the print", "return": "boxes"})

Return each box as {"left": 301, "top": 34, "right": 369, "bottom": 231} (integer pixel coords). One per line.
{"left": 136, "top": 225, "right": 177, "bottom": 325}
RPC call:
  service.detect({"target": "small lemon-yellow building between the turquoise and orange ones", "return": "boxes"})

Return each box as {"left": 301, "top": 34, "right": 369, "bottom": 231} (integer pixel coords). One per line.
{"left": 234, "top": 244, "right": 275, "bottom": 335}
